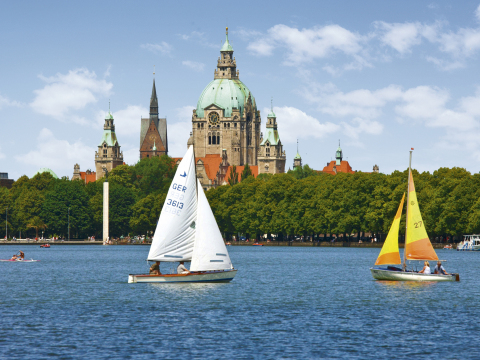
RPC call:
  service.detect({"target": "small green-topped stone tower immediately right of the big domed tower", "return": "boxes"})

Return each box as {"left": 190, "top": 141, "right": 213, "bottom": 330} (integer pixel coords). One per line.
{"left": 258, "top": 107, "right": 286, "bottom": 174}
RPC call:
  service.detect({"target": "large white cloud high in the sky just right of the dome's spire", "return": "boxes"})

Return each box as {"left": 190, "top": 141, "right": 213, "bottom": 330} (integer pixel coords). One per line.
{"left": 248, "top": 24, "right": 364, "bottom": 65}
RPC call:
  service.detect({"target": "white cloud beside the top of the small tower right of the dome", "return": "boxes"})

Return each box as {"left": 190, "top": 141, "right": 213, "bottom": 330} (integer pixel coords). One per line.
{"left": 263, "top": 106, "right": 340, "bottom": 144}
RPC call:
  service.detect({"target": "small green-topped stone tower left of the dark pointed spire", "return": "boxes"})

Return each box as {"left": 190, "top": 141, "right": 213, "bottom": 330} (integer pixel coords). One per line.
{"left": 94, "top": 109, "right": 123, "bottom": 180}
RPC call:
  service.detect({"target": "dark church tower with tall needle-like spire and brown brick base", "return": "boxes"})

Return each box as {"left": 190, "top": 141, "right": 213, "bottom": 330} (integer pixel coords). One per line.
{"left": 140, "top": 72, "right": 168, "bottom": 160}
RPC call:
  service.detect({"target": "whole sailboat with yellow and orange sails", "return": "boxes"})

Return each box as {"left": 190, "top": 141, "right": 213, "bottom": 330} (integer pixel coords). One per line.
{"left": 370, "top": 149, "right": 460, "bottom": 281}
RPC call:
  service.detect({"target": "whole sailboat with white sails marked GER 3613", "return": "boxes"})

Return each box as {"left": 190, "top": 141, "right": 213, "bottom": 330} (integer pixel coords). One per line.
{"left": 128, "top": 146, "right": 237, "bottom": 283}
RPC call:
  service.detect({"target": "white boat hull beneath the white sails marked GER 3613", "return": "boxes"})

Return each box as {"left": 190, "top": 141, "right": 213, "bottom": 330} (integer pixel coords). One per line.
{"left": 128, "top": 270, "right": 237, "bottom": 284}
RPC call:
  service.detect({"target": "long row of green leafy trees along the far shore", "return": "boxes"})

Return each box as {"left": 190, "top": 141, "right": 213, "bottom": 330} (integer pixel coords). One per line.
{"left": 0, "top": 156, "right": 480, "bottom": 240}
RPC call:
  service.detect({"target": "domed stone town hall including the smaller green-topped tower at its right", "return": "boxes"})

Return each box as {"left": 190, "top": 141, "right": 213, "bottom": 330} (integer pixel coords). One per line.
{"left": 187, "top": 28, "right": 286, "bottom": 189}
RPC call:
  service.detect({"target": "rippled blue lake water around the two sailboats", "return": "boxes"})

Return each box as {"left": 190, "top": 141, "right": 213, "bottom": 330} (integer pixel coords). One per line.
{"left": 0, "top": 245, "right": 480, "bottom": 359}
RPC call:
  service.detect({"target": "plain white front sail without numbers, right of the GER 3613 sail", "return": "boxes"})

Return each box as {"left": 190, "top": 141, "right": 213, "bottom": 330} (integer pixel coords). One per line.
{"left": 190, "top": 182, "right": 233, "bottom": 271}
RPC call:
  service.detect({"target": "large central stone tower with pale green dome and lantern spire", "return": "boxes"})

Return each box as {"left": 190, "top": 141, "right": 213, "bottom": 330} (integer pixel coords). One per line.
{"left": 189, "top": 28, "right": 261, "bottom": 166}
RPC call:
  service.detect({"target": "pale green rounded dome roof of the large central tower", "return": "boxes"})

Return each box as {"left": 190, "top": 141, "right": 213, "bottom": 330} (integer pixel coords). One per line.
{"left": 197, "top": 79, "right": 257, "bottom": 118}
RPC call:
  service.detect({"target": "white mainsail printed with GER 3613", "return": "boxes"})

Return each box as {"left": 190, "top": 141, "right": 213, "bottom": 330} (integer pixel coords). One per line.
{"left": 148, "top": 146, "right": 197, "bottom": 262}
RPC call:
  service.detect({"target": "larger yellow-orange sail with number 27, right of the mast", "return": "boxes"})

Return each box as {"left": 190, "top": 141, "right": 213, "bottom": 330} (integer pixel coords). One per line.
{"left": 405, "top": 172, "right": 438, "bottom": 260}
